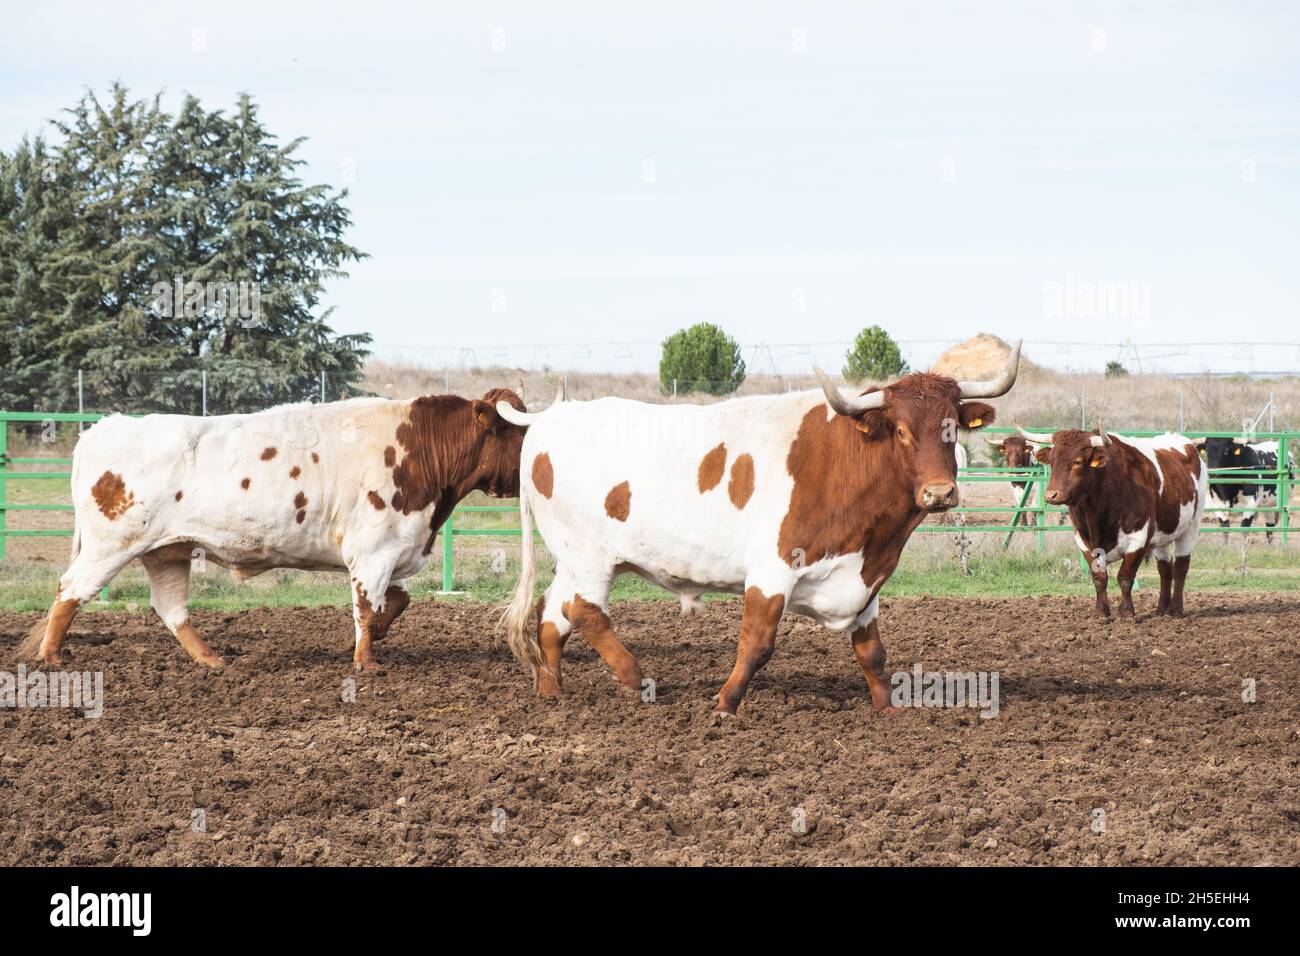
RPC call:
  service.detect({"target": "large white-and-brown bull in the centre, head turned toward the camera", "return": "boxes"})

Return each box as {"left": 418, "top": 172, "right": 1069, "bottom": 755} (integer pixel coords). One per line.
{"left": 498, "top": 343, "right": 1019, "bottom": 714}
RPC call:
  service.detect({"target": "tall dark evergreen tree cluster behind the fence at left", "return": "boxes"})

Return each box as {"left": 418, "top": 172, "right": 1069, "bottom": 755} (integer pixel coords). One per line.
{"left": 0, "top": 86, "right": 371, "bottom": 414}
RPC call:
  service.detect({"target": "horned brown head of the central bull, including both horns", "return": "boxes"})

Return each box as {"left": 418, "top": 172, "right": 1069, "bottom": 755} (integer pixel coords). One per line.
{"left": 814, "top": 342, "right": 1021, "bottom": 511}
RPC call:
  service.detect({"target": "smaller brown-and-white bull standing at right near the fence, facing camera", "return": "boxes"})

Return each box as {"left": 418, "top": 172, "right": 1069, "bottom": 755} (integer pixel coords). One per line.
{"left": 1021, "top": 428, "right": 1209, "bottom": 618}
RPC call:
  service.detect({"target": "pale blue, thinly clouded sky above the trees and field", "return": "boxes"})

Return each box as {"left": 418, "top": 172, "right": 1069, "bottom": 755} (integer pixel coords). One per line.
{"left": 0, "top": 0, "right": 1300, "bottom": 372}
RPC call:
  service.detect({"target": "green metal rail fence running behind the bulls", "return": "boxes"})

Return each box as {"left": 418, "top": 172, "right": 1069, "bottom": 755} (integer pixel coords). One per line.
{"left": 0, "top": 411, "right": 1300, "bottom": 591}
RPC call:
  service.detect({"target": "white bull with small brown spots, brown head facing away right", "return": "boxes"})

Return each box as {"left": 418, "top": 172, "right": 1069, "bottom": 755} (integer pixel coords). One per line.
{"left": 22, "top": 389, "right": 524, "bottom": 670}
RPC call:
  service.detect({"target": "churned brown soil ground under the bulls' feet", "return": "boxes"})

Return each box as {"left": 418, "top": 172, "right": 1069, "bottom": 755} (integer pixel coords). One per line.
{"left": 0, "top": 593, "right": 1300, "bottom": 865}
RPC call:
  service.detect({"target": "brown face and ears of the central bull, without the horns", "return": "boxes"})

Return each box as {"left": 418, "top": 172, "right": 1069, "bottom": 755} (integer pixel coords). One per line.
{"left": 857, "top": 382, "right": 995, "bottom": 511}
